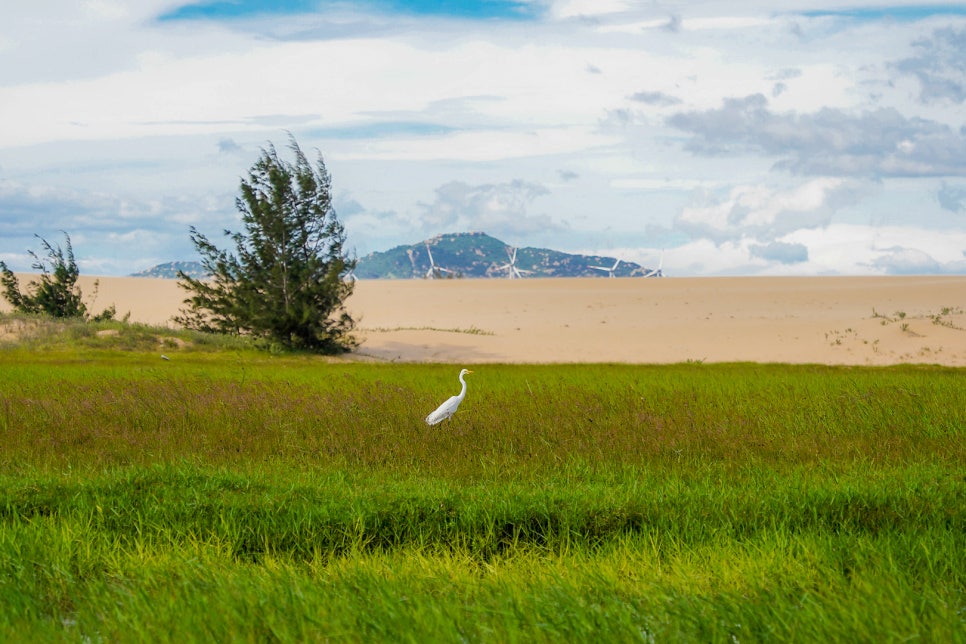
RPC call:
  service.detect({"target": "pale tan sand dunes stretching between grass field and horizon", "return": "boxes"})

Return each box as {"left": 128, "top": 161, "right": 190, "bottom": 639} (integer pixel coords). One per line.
{"left": 0, "top": 275, "right": 966, "bottom": 366}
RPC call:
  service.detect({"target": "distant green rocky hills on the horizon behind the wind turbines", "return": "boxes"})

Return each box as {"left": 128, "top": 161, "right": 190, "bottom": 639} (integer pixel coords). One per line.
{"left": 132, "top": 233, "right": 648, "bottom": 279}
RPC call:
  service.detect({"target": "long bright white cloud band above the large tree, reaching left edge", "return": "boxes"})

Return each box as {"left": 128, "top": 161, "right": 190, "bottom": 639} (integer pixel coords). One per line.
{"left": 0, "top": 39, "right": 643, "bottom": 146}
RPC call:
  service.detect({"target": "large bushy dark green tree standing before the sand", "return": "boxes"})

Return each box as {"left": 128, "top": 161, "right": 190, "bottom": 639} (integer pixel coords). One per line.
{"left": 175, "top": 138, "right": 355, "bottom": 353}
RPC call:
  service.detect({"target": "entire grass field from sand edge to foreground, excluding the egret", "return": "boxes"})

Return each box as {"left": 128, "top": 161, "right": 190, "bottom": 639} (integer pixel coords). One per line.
{"left": 0, "top": 320, "right": 966, "bottom": 642}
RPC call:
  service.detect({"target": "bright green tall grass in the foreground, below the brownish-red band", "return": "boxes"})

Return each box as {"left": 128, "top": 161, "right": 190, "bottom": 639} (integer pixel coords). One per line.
{"left": 0, "top": 465, "right": 966, "bottom": 641}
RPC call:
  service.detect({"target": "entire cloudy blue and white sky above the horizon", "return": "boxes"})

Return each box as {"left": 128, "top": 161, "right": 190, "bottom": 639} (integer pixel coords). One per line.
{"left": 0, "top": 0, "right": 966, "bottom": 276}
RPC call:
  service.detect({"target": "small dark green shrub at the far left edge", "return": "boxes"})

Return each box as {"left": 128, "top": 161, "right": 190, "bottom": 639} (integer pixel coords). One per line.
{"left": 0, "top": 233, "right": 115, "bottom": 321}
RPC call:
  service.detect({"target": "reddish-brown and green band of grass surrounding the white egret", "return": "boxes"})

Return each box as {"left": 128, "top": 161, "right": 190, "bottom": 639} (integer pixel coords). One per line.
{"left": 0, "top": 353, "right": 966, "bottom": 472}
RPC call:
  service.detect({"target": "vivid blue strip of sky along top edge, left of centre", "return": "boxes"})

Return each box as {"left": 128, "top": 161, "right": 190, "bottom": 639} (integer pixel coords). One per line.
{"left": 159, "top": 0, "right": 537, "bottom": 21}
